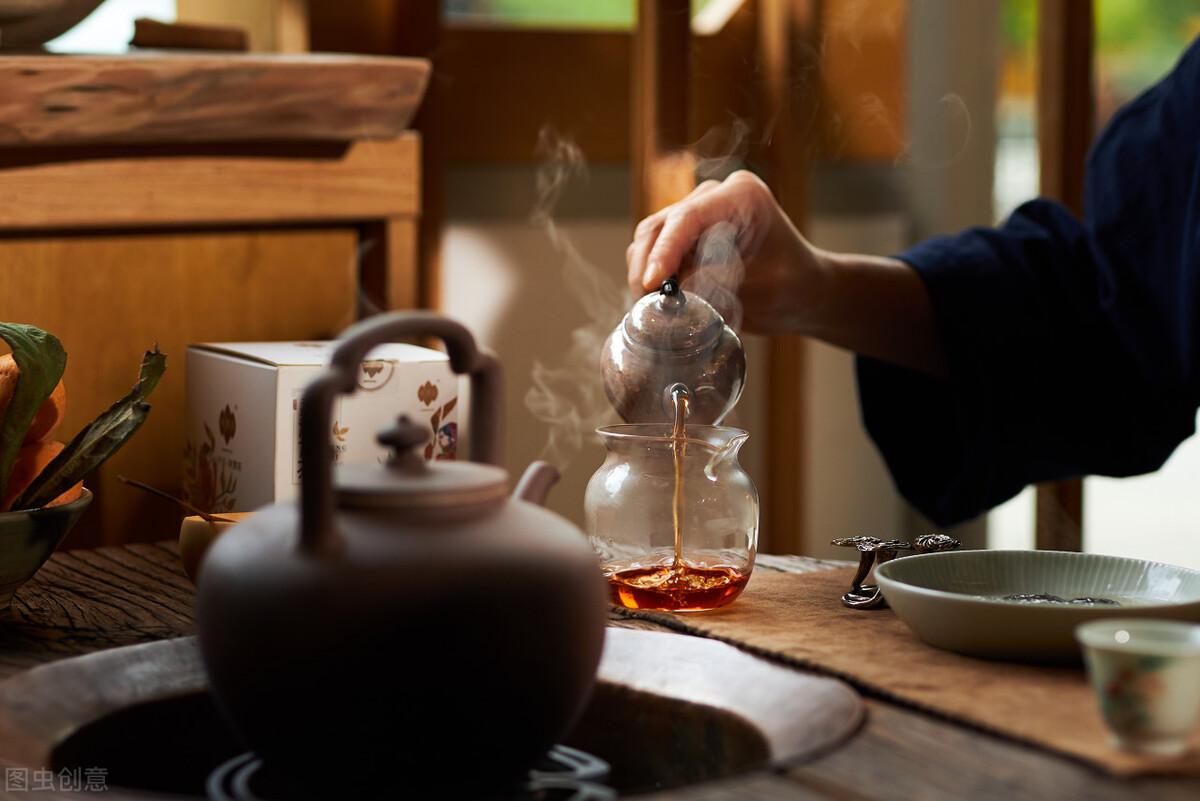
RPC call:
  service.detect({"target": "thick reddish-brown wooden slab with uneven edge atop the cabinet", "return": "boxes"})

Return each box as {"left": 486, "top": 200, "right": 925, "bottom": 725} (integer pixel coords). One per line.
{"left": 0, "top": 50, "right": 430, "bottom": 146}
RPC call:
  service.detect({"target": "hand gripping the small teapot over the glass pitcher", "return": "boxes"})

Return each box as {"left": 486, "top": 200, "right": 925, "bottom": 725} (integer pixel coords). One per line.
{"left": 625, "top": 171, "right": 827, "bottom": 333}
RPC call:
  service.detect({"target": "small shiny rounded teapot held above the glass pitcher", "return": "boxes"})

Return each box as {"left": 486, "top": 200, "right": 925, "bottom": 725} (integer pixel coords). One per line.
{"left": 600, "top": 278, "right": 746, "bottom": 424}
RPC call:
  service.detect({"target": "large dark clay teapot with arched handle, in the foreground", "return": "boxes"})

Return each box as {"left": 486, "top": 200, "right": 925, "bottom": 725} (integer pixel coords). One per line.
{"left": 197, "top": 313, "right": 606, "bottom": 797}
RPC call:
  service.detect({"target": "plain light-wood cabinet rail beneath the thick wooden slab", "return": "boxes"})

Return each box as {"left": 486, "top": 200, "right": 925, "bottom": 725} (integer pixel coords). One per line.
{"left": 0, "top": 135, "right": 420, "bottom": 231}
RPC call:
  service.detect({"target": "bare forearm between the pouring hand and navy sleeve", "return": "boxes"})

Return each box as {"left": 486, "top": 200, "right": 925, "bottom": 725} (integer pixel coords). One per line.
{"left": 800, "top": 251, "right": 947, "bottom": 377}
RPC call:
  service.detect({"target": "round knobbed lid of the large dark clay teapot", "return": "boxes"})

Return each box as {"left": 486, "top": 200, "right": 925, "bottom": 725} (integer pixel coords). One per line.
{"left": 335, "top": 415, "right": 509, "bottom": 517}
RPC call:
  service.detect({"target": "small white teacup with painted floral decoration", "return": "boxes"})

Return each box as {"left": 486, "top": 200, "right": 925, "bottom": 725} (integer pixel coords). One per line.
{"left": 1075, "top": 618, "right": 1200, "bottom": 757}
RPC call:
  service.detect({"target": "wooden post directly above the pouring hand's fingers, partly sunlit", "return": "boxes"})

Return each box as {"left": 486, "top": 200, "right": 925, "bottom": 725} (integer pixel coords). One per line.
{"left": 630, "top": 0, "right": 695, "bottom": 221}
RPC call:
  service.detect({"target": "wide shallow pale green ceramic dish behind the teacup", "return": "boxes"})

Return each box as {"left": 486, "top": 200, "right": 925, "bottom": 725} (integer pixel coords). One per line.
{"left": 875, "top": 550, "right": 1200, "bottom": 663}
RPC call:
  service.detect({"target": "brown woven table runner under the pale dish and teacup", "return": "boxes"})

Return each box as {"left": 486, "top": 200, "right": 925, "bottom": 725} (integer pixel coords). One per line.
{"left": 623, "top": 570, "right": 1200, "bottom": 776}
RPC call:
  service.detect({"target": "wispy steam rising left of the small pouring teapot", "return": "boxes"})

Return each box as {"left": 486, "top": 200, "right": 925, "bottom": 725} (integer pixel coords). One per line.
{"left": 524, "top": 128, "right": 625, "bottom": 470}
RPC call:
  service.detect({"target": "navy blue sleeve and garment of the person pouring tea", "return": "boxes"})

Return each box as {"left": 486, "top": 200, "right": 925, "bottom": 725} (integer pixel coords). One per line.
{"left": 858, "top": 40, "right": 1200, "bottom": 525}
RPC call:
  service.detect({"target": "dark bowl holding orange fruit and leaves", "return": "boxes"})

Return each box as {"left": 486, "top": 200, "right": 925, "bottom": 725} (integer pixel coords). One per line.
{"left": 0, "top": 488, "right": 91, "bottom": 612}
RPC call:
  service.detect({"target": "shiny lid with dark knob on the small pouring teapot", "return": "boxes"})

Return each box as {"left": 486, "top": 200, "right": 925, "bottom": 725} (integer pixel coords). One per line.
{"left": 624, "top": 278, "right": 725, "bottom": 351}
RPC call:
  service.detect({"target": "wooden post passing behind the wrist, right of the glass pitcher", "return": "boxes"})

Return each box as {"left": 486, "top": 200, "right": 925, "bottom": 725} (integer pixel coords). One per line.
{"left": 757, "top": 0, "right": 820, "bottom": 553}
